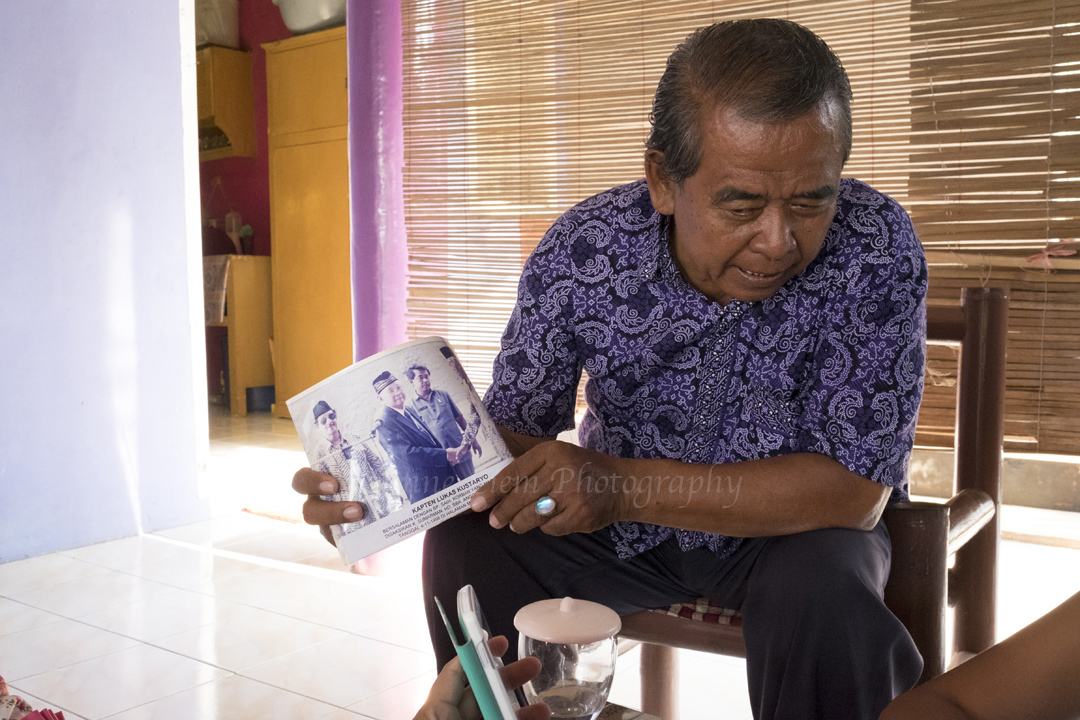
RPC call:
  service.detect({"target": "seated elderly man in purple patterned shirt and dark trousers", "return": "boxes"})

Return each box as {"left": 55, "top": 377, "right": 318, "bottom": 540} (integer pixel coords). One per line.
{"left": 295, "top": 21, "right": 927, "bottom": 719}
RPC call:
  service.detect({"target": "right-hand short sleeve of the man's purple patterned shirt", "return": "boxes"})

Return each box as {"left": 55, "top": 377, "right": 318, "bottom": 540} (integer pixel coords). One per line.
{"left": 798, "top": 199, "right": 927, "bottom": 490}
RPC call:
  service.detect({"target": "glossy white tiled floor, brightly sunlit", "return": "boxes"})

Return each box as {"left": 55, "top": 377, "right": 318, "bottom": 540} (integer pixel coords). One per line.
{"left": 0, "top": 405, "right": 1080, "bottom": 720}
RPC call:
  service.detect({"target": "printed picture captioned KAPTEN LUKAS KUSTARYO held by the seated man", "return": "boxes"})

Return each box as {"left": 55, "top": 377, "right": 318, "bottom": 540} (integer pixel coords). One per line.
{"left": 287, "top": 338, "right": 513, "bottom": 565}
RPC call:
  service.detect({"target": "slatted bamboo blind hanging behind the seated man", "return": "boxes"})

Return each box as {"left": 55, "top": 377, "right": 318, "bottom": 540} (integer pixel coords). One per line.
{"left": 402, "top": 0, "right": 1080, "bottom": 452}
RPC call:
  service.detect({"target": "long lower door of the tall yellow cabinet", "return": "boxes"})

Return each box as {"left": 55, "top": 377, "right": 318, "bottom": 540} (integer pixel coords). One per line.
{"left": 270, "top": 139, "right": 352, "bottom": 417}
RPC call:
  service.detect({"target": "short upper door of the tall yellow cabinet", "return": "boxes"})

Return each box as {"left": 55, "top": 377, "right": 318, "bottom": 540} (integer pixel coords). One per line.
{"left": 267, "top": 32, "right": 349, "bottom": 137}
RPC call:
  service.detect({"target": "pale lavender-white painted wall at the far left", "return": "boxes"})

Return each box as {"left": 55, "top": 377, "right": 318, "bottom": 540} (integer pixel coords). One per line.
{"left": 0, "top": 0, "right": 208, "bottom": 562}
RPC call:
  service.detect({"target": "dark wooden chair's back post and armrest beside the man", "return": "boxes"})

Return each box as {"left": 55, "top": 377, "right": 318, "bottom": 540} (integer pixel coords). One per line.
{"left": 886, "top": 287, "right": 1009, "bottom": 680}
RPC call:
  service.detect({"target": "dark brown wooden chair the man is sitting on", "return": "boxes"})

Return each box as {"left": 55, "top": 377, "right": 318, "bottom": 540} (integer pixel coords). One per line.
{"left": 620, "top": 288, "right": 1009, "bottom": 720}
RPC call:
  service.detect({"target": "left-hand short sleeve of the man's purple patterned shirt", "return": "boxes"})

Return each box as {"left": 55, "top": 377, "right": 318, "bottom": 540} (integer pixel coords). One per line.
{"left": 484, "top": 223, "right": 582, "bottom": 437}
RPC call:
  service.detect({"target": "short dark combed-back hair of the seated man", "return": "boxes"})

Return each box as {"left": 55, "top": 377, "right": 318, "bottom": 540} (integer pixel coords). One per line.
{"left": 645, "top": 19, "right": 851, "bottom": 184}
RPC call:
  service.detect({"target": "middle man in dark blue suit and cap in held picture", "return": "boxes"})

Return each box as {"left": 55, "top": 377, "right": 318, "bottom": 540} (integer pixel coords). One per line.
{"left": 372, "top": 371, "right": 458, "bottom": 502}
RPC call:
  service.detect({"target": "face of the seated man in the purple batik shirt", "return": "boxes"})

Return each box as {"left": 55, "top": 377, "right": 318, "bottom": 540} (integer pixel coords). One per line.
{"left": 645, "top": 103, "right": 843, "bottom": 304}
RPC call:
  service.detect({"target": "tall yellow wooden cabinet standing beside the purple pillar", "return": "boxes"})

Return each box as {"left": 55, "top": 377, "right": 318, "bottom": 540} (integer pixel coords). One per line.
{"left": 264, "top": 28, "right": 352, "bottom": 418}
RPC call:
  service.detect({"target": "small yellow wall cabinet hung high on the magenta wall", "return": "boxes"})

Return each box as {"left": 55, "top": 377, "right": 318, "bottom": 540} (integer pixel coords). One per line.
{"left": 195, "top": 45, "right": 255, "bottom": 161}
